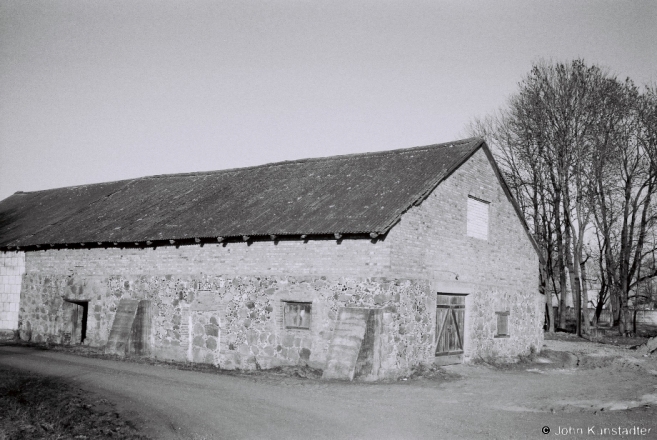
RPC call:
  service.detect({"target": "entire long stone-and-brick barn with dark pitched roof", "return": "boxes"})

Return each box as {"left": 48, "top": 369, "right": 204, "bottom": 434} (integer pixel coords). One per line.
{"left": 0, "top": 139, "right": 545, "bottom": 379}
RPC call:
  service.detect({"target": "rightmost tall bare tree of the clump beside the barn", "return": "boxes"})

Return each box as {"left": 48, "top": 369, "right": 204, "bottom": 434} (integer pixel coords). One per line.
{"left": 593, "top": 81, "right": 657, "bottom": 334}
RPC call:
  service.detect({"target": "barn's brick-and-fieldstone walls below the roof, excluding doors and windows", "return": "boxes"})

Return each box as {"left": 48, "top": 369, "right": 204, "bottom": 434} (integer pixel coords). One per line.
{"left": 12, "top": 146, "right": 544, "bottom": 378}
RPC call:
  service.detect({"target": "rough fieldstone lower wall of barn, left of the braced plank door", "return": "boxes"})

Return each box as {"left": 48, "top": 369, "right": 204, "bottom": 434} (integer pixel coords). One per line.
{"left": 21, "top": 274, "right": 435, "bottom": 377}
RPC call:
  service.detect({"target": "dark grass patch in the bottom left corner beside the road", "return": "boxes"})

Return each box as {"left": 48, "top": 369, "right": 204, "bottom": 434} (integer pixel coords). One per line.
{"left": 0, "top": 367, "right": 148, "bottom": 440}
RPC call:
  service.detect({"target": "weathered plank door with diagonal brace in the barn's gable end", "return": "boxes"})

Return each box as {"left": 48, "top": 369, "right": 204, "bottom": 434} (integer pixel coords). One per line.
{"left": 436, "top": 294, "right": 465, "bottom": 365}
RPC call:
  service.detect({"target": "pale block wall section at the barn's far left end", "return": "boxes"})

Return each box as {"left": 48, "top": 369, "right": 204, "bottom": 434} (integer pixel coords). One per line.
{"left": 0, "top": 252, "right": 25, "bottom": 330}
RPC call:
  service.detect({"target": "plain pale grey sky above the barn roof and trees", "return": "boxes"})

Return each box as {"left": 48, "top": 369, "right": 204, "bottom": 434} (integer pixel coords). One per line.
{"left": 0, "top": 0, "right": 657, "bottom": 199}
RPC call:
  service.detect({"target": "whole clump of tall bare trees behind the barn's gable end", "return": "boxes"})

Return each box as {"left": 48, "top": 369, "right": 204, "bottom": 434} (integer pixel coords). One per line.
{"left": 469, "top": 60, "right": 657, "bottom": 335}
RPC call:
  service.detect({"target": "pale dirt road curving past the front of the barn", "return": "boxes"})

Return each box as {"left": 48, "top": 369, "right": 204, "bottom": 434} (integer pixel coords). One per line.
{"left": 0, "top": 346, "right": 657, "bottom": 439}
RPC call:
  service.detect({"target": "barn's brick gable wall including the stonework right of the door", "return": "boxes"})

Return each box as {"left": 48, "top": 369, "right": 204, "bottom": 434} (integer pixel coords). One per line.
{"left": 386, "top": 150, "right": 545, "bottom": 360}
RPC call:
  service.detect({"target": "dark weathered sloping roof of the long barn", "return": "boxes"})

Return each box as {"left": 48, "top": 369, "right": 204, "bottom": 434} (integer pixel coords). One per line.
{"left": 0, "top": 139, "right": 483, "bottom": 248}
